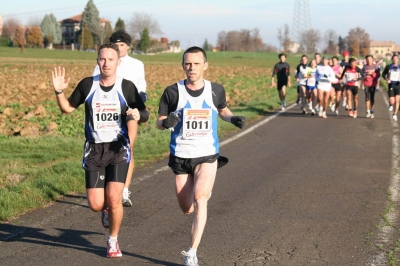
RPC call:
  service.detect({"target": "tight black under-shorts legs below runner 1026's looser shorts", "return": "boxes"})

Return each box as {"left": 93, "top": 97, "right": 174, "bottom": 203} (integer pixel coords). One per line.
{"left": 85, "top": 163, "right": 129, "bottom": 188}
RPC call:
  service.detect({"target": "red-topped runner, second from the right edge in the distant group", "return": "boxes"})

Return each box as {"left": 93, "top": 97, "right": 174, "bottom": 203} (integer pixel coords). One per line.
{"left": 362, "top": 55, "right": 381, "bottom": 118}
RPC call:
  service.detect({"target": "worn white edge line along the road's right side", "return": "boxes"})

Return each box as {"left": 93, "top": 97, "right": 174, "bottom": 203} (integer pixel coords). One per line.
{"left": 367, "top": 91, "right": 400, "bottom": 266}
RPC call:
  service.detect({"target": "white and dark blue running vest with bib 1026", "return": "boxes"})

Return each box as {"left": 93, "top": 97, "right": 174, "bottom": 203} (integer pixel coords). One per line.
{"left": 85, "top": 75, "right": 128, "bottom": 143}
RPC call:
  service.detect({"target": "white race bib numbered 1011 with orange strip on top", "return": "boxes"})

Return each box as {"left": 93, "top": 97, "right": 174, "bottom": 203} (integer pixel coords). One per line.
{"left": 182, "top": 108, "right": 212, "bottom": 139}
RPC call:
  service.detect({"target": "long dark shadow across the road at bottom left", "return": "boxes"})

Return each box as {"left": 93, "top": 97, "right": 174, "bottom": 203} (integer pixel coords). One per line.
{"left": 0, "top": 224, "right": 181, "bottom": 266}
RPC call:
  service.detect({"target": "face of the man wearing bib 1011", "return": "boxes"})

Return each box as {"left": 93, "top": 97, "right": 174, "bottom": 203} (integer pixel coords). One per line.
{"left": 182, "top": 52, "right": 208, "bottom": 82}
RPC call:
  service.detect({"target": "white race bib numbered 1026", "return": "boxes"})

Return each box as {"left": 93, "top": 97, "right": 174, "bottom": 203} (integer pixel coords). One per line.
{"left": 93, "top": 101, "right": 121, "bottom": 131}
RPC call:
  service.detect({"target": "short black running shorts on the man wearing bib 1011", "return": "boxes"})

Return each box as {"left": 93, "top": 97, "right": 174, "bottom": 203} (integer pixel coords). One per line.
{"left": 168, "top": 154, "right": 228, "bottom": 175}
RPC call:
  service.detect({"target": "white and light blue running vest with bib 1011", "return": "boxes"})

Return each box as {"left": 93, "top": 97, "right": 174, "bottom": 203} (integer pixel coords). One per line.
{"left": 170, "top": 80, "right": 219, "bottom": 158}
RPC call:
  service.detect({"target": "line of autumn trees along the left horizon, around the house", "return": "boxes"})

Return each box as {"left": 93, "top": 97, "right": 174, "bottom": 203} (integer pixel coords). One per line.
{"left": 2, "top": 0, "right": 179, "bottom": 53}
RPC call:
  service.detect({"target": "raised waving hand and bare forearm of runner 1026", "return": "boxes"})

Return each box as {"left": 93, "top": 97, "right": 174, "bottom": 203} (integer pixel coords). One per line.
{"left": 51, "top": 67, "right": 75, "bottom": 114}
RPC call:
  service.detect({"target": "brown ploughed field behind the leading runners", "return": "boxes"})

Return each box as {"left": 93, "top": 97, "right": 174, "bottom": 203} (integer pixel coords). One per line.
{"left": 0, "top": 60, "right": 269, "bottom": 136}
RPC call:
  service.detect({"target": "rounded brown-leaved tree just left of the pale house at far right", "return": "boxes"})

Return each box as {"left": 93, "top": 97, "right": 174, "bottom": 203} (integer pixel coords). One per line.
{"left": 346, "top": 27, "right": 370, "bottom": 56}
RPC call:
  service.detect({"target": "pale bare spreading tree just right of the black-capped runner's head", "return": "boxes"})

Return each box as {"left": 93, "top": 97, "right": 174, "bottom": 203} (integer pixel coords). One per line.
{"left": 128, "top": 12, "right": 163, "bottom": 39}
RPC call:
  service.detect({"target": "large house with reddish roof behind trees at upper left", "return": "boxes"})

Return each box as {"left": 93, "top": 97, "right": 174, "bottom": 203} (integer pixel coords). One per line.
{"left": 60, "top": 14, "right": 110, "bottom": 46}
